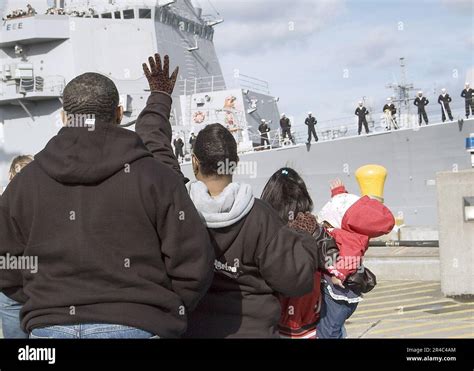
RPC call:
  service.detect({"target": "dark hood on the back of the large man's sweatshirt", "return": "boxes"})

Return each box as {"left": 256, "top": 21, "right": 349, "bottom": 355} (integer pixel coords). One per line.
{"left": 35, "top": 124, "right": 152, "bottom": 184}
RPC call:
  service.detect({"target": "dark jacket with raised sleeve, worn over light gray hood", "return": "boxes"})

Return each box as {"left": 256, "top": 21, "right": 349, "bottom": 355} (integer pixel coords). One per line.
{"left": 136, "top": 93, "right": 335, "bottom": 338}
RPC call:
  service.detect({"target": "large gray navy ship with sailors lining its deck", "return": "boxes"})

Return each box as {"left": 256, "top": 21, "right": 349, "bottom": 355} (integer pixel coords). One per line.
{"left": 0, "top": 0, "right": 474, "bottom": 230}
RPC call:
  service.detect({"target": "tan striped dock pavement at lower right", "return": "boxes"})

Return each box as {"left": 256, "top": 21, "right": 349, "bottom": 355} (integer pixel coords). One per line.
{"left": 346, "top": 281, "right": 474, "bottom": 338}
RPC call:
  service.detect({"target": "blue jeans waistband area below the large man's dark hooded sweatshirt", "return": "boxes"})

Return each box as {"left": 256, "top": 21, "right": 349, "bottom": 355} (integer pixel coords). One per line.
{"left": 30, "top": 323, "right": 159, "bottom": 339}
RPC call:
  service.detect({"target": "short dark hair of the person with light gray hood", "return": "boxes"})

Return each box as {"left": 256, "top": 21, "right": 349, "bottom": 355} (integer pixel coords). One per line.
{"left": 193, "top": 124, "right": 239, "bottom": 176}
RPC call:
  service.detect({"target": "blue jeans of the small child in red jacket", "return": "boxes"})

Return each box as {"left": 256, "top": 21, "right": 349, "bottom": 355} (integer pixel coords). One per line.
{"left": 316, "top": 285, "right": 359, "bottom": 339}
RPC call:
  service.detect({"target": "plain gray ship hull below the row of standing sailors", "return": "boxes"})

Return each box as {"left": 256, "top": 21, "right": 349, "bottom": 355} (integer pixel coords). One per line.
{"left": 182, "top": 119, "right": 474, "bottom": 227}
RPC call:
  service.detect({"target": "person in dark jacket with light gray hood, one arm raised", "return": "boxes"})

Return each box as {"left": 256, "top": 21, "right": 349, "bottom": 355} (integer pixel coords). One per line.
{"left": 136, "top": 54, "right": 338, "bottom": 338}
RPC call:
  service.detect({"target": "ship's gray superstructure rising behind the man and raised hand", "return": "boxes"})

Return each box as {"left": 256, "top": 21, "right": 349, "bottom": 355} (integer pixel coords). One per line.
{"left": 0, "top": 0, "right": 278, "bottom": 171}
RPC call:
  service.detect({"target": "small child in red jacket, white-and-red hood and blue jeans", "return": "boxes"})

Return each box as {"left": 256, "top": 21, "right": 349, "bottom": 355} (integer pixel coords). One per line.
{"left": 317, "top": 179, "right": 395, "bottom": 338}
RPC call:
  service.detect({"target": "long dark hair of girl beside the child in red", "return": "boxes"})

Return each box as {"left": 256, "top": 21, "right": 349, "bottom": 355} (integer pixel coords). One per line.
{"left": 261, "top": 167, "right": 313, "bottom": 223}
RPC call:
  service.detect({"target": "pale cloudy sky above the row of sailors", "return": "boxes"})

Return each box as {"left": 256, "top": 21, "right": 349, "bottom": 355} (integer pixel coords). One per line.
{"left": 194, "top": 0, "right": 474, "bottom": 133}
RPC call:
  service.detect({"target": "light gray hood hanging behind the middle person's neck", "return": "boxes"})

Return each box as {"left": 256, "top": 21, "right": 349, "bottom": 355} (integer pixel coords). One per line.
{"left": 188, "top": 181, "right": 255, "bottom": 229}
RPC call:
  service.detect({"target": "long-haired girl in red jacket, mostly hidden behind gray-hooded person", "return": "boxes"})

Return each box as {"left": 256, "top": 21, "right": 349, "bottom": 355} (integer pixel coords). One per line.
{"left": 262, "top": 167, "right": 336, "bottom": 339}
